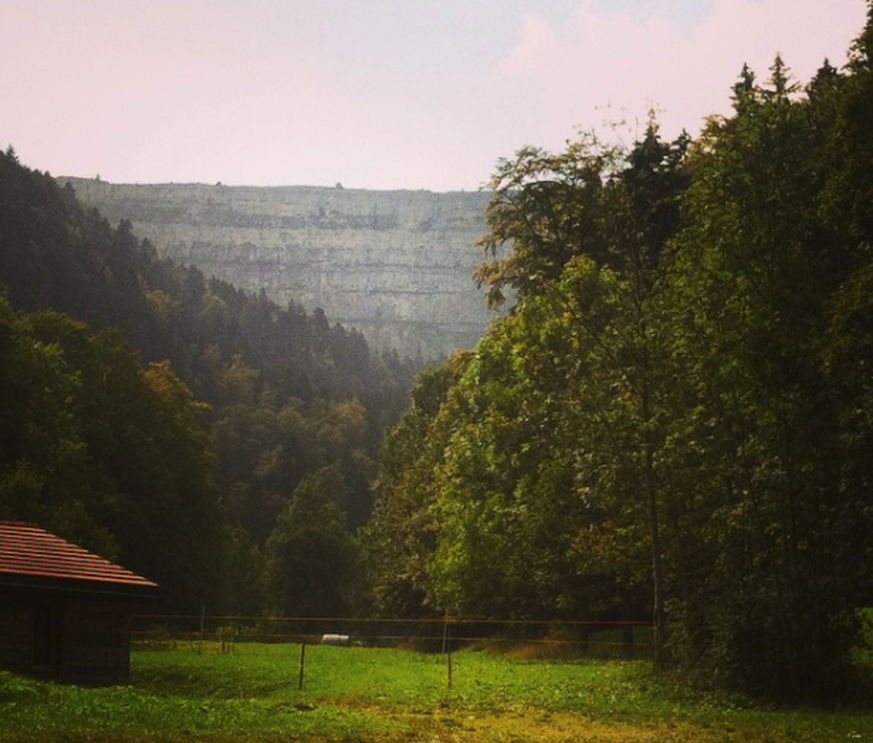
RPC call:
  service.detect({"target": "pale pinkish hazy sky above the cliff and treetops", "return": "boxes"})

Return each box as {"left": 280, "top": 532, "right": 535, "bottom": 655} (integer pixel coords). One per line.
{"left": 0, "top": 0, "right": 866, "bottom": 191}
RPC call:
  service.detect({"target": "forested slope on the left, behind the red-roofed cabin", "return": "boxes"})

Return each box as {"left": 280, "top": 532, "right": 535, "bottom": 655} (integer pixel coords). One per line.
{"left": 0, "top": 147, "right": 416, "bottom": 613}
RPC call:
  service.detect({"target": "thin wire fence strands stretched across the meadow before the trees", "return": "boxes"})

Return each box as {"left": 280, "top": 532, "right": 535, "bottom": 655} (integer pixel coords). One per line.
{"left": 131, "top": 611, "right": 652, "bottom": 659}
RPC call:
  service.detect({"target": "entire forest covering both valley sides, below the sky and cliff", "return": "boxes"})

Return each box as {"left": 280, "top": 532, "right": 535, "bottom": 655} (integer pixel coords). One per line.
{"left": 0, "top": 6, "right": 873, "bottom": 701}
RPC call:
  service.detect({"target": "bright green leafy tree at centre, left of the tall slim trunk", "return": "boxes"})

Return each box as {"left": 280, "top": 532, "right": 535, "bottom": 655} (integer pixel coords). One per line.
{"left": 429, "top": 268, "right": 645, "bottom": 619}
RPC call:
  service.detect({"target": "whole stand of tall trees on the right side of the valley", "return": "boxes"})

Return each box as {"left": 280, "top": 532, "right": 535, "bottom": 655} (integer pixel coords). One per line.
{"left": 367, "top": 9, "right": 873, "bottom": 699}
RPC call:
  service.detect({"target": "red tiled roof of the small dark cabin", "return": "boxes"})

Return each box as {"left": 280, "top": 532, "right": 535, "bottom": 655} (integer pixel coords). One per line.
{"left": 0, "top": 521, "right": 157, "bottom": 593}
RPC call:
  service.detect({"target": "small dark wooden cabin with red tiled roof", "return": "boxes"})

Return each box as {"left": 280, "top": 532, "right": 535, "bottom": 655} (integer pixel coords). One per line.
{"left": 0, "top": 521, "right": 158, "bottom": 685}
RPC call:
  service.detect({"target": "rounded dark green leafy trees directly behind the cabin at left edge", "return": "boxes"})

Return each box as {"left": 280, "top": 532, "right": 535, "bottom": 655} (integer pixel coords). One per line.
{"left": 0, "top": 300, "right": 221, "bottom": 610}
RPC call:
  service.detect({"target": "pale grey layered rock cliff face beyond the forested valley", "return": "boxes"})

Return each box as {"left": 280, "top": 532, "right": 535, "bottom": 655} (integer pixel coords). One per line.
{"left": 59, "top": 178, "right": 493, "bottom": 359}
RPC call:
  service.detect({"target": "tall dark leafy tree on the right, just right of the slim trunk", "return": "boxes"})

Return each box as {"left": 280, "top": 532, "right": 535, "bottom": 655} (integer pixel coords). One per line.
{"left": 664, "top": 58, "right": 861, "bottom": 696}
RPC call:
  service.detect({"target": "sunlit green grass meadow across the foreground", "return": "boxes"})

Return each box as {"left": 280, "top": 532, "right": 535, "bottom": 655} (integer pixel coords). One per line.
{"left": 0, "top": 644, "right": 873, "bottom": 743}
